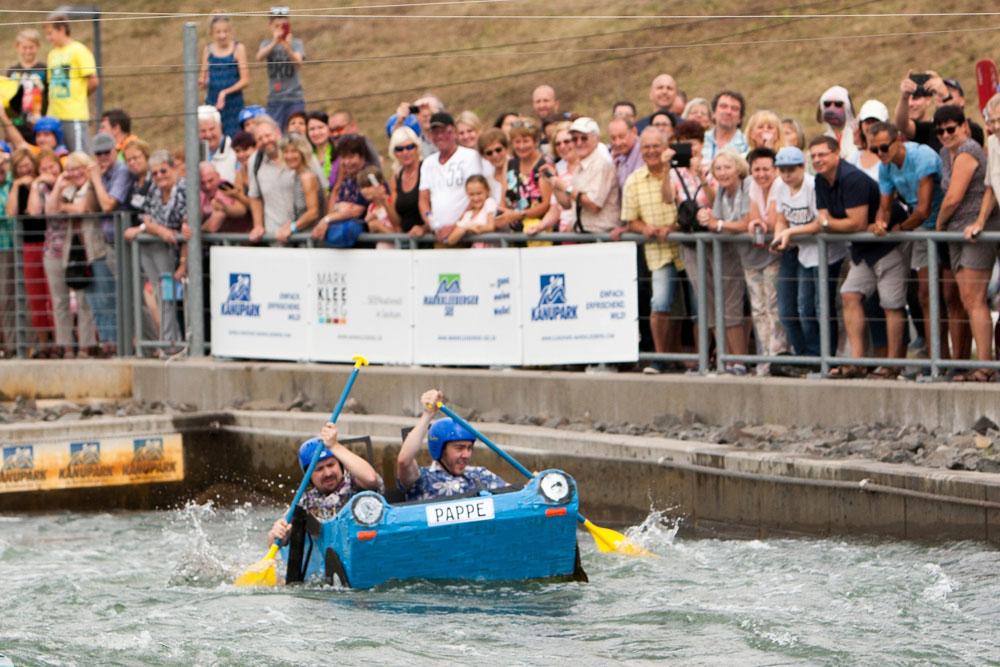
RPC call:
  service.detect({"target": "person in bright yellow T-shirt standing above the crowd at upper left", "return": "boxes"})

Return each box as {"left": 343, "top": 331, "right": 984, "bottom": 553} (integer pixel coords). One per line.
{"left": 45, "top": 14, "right": 99, "bottom": 153}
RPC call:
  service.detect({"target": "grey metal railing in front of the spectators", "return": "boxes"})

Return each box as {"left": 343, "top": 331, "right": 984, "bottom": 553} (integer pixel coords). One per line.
{"left": 1, "top": 212, "right": 1000, "bottom": 380}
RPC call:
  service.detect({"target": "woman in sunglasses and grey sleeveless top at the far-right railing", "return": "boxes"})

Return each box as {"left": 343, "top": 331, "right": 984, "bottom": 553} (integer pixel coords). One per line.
{"left": 934, "top": 106, "right": 1000, "bottom": 382}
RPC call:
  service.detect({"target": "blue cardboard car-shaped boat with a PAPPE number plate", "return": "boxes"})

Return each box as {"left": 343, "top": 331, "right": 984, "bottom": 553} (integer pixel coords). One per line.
{"left": 282, "top": 469, "right": 587, "bottom": 588}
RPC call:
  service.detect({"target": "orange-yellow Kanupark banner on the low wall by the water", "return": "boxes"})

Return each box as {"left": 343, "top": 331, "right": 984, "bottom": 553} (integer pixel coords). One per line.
{"left": 0, "top": 433, "right": 184, "bottom": 493}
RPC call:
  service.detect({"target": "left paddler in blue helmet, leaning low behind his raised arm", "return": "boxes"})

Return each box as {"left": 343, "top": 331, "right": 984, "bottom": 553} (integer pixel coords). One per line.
{"left": 267, "top": 422, "right": 385, "bottom": 544}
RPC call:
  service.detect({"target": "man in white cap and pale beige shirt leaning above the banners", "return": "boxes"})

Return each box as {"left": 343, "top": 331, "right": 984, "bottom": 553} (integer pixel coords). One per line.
{"left": 552, "top": 117, "right": 621, "bottom": 233}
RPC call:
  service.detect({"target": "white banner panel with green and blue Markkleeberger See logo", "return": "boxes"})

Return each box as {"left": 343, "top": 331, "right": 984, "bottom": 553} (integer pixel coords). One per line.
{"left": 413, "top": 248, "right": 521, "bottom": 365}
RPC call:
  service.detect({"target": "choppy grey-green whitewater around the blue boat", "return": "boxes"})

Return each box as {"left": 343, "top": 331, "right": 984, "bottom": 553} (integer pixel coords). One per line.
{"left": 0, "top": 505, "right": 1000, "bottom": 666}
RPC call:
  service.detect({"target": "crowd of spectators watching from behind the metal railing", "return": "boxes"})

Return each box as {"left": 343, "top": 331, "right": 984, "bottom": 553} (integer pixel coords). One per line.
{"left": 0, "top": 7, "right": 1000, "bottom": 381}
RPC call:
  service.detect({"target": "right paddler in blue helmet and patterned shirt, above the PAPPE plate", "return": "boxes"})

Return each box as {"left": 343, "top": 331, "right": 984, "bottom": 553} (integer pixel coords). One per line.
{"left": 396, "top": 389, "right": 507, "bottom": 500}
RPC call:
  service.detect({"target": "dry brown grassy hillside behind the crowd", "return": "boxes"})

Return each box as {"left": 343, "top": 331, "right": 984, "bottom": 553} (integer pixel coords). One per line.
{"left": 0, "top": 0, "right": 1000, "bottom": 154}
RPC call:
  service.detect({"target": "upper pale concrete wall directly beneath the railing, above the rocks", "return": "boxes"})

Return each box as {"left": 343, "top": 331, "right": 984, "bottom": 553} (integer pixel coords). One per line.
{"left": 133, "top": 361, "right": 1000, "bottom": 430}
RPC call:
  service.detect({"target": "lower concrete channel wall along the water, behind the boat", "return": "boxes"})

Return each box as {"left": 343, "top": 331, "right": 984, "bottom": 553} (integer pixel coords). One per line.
{"left": 7, "top": 411, "right": 1000, "bottom": 543}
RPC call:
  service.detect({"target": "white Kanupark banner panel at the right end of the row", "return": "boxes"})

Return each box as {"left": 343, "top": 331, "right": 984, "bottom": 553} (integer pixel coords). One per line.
{"left": 521, "top": 242, "right": 639, "bottom": 366}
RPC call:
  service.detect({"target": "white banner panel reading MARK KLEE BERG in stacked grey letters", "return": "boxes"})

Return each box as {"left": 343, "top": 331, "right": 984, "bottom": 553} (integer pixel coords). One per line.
{"left": 307, "top": 249, "right": 413, "bottom": 364}
